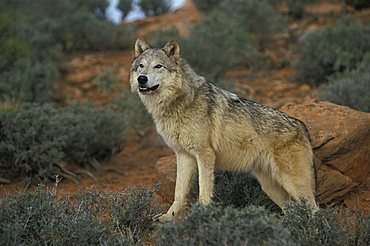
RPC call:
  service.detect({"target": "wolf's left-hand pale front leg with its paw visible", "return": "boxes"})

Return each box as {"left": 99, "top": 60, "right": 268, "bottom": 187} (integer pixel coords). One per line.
{"left": 158, "top": 153, "right": 196, "bottom": 223}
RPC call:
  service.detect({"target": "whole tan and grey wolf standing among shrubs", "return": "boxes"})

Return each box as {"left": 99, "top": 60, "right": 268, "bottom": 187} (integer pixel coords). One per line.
{"left": 130, "top": 38, "right": 316, "bottom": 222}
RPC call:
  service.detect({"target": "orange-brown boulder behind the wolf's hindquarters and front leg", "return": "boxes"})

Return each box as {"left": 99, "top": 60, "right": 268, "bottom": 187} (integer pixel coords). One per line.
{"left": 156, "top": 100, "right": 370, "bottom": 204}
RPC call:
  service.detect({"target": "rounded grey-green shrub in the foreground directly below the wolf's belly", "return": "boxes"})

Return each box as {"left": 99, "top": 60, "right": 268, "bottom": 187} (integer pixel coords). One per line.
{"left": 157, "top": 204, "right": 293, "bottom": 245}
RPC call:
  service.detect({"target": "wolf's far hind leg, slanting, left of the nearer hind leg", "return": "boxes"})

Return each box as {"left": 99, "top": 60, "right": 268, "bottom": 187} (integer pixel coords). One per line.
{"left": 255, "top": 173, "right": 290, "bottom": 209}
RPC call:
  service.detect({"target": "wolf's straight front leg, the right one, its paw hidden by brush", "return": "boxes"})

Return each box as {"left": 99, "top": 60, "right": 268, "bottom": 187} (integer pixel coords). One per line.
{"left": 197, "top": 148, "right": 216, "bottom": 205}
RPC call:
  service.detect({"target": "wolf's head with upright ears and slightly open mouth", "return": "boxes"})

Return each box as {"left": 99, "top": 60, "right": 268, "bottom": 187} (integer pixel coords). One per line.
{"left": 130, "top": 38, "right": 180, "bottom": 97}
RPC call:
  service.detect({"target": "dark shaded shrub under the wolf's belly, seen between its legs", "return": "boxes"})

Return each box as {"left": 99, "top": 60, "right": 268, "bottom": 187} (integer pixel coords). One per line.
{"left": 191, "top": 171, "right": 280, "bottom": 211}
